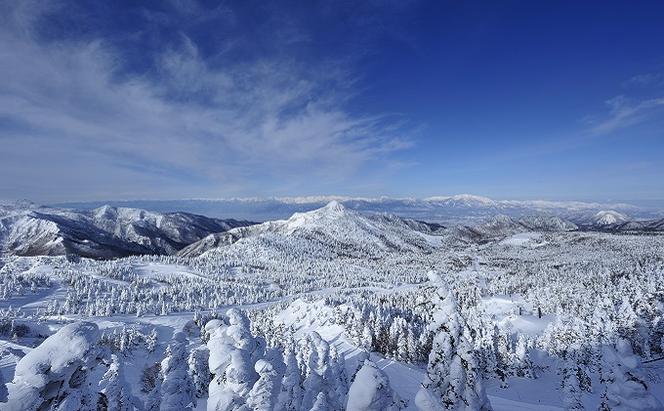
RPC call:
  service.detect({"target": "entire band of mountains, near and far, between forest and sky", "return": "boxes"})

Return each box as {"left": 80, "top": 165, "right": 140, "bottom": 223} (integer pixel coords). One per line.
{"left": 0, "top": 195, "right": 664, "bottom": 258}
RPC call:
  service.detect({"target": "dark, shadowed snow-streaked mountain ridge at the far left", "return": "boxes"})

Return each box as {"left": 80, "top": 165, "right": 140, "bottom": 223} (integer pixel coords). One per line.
{"left": 0, "top": 203, "right": 250, "bottom": 258}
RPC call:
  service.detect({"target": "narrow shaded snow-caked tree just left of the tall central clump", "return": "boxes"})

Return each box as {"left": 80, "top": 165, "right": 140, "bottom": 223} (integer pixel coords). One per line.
{"left": 159, "top": 332, "right": 196, "bottom": 411}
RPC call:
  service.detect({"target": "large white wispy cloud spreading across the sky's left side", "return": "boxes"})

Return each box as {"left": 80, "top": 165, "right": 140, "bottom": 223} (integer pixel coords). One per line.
{"left": 0, "top": 2, "right": 412, "bottom": 200}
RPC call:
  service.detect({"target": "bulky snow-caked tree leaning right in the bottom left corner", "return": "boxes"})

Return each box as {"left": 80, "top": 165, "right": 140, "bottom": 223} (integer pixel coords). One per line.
{"left": 2, "top": 322, "right": 99, "bottom": 411}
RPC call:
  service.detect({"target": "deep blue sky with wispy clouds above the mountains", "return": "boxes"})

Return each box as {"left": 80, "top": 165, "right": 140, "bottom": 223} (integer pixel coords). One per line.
{"left": 0, "top": 0, "right": 664, "bottom": 202}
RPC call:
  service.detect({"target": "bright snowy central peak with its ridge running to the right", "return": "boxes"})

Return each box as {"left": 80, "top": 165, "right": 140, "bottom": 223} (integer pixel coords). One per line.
{"left": 178, "top": 200, "right": 664, "bottom": 258}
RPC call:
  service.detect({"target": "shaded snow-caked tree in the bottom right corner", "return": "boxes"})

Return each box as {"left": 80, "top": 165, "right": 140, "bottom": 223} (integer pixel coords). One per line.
{"left": 599, "top": 339, "right": 664, "bottom": 411}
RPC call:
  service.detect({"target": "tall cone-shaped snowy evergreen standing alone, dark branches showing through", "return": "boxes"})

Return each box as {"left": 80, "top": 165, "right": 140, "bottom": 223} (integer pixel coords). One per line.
{"left": 415, "top": 273, "right": 491, "bottom": 411}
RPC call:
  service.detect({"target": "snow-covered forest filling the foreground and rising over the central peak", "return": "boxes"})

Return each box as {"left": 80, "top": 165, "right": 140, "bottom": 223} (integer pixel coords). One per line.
{"left": 0, "top": 203, "right": 664, "bottom": 411}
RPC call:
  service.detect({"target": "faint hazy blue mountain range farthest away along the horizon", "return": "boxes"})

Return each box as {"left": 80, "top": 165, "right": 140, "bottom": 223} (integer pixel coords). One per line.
{"left": 54, "top": 194, "right": 664, "bottom": 225}
